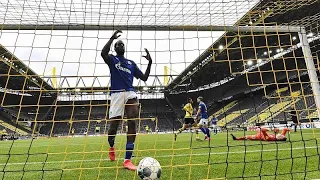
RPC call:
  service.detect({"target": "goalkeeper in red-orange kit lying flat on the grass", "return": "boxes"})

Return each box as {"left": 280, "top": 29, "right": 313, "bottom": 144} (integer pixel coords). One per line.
{"left": 231, "top": 128, "right": 289, "bottom": 141}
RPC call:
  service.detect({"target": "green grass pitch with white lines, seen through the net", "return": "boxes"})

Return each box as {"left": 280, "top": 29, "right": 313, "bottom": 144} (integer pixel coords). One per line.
{"left": 0, "top": 130, "right": 320, "bottom": 180}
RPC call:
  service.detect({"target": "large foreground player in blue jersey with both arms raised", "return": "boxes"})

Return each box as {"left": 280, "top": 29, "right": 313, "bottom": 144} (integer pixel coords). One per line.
{"left": 101, "top": 30, "right": 152, "bottom": 170}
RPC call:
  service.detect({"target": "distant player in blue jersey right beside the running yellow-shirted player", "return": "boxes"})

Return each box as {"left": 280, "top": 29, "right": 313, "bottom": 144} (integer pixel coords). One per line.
{"left": 196, "top": 96, "right": 210, "bottom": 140}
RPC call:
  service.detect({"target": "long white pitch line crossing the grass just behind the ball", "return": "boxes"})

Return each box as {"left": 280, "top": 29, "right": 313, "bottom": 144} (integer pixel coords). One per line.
{"left": 0, "top": 146, "right": 318, "bottom": 166}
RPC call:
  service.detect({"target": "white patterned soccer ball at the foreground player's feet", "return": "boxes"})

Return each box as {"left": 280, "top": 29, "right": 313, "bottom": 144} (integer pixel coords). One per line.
{"left": 137, "top": 157, "right": 161, "bottom": 180}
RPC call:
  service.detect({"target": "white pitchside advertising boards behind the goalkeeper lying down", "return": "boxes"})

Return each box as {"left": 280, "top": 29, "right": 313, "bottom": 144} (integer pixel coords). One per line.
{"left": 248, "top": 120, "right": 320, "bottom": 131}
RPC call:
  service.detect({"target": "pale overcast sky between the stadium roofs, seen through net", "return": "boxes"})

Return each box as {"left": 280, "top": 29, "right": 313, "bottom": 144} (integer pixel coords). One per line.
{"left": 0, "top": 0, "right": 258, "bottom": 86}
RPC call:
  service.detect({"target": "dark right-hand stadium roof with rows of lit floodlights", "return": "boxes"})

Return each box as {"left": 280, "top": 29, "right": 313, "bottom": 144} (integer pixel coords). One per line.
{"left": 167, "top": 0, "right": 320, "bottom": 91}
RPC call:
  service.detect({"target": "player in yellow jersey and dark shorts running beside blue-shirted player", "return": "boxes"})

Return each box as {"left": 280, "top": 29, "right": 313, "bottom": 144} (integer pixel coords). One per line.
{"left": 174, "top": 98, "right": 198, "bottom": 141}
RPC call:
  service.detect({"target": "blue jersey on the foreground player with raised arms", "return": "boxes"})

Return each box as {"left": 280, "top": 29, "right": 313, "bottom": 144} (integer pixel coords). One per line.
{"left": 107, "top": 54, "right": 143, "bottom": 93}
